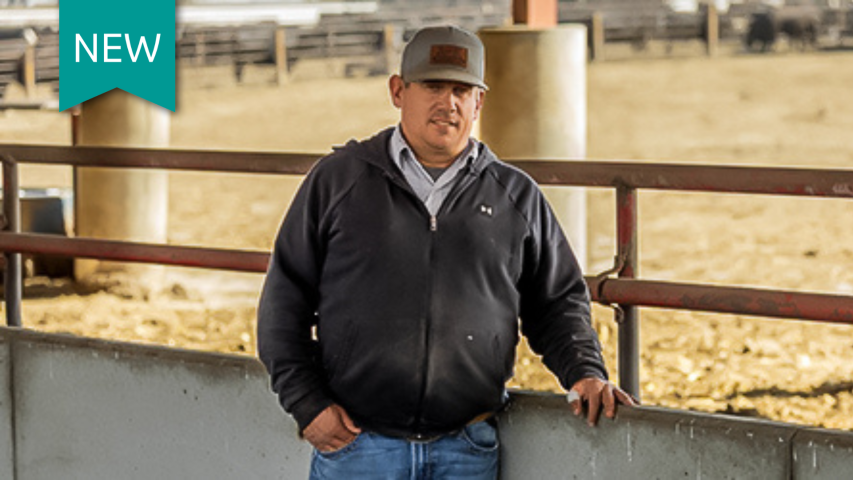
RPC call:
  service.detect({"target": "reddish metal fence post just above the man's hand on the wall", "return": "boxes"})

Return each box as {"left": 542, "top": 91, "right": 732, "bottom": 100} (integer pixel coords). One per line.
{"left": 616, "top": 186, "right": 640, "bottom": 398}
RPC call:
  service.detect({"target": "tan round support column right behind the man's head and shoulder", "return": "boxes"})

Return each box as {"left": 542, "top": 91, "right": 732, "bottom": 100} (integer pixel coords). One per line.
{"left": 479, "top": 24, "right": 587, "bottom": 268}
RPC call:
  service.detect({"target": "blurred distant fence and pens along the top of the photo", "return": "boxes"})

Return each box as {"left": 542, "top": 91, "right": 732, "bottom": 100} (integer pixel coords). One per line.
{"left": 0, "top": 0, "right": 853, "bottom": 106}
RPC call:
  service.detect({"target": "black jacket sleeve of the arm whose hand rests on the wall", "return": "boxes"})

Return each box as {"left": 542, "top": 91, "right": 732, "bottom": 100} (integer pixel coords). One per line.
{"left": 519, "top": 189, "right": 608, "bottom": 390}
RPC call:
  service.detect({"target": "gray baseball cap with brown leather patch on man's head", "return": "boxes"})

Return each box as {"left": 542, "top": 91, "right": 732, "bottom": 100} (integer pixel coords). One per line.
{"left": 400, "top": 26, "right": 488, "bottom": 88}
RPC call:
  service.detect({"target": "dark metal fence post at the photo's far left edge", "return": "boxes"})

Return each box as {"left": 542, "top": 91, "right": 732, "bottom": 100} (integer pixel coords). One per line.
{"left": 2, "top": 155, "right": 22, "bottom": 327}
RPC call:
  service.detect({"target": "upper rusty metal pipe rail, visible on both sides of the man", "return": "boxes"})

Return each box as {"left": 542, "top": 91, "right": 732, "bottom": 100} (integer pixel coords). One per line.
{"left": 5, "top": 144, "right": 853, "bottom": 198}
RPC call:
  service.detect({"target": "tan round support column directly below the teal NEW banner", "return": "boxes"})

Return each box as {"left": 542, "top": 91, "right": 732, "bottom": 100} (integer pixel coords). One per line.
{"left": 74, "top": 89, "right": 171, "bottom": 289}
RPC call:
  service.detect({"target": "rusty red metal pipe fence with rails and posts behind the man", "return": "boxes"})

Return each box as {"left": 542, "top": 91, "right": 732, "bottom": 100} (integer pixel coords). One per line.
{"left": 0, "top": 145, "right": 853, "bottom": 396}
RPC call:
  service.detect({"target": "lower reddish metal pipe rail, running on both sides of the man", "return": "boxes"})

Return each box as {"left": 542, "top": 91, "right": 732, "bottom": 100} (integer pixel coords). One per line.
{"left": 0, "top": 232, "right": 853, "bottom": 324}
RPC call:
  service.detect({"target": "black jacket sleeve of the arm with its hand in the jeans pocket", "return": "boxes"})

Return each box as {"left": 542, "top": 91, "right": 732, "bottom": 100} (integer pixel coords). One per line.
{"left": 257, "top": 164, "right": 333, "bottom": 432}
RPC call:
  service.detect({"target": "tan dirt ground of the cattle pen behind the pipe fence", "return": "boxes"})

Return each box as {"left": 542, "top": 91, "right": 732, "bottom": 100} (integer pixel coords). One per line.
{"left": 0, "top": 52, "right": 853, "bottom": 429}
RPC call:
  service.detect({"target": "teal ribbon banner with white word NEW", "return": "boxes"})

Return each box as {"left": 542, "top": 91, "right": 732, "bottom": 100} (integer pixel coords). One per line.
{"left": 59, "top": 0, "right": 175, "bottom": 112}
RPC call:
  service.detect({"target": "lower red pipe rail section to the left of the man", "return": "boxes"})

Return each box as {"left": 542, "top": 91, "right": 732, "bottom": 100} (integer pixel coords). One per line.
{"left": 0, "top": 232, "right": 269, "bottom": 273}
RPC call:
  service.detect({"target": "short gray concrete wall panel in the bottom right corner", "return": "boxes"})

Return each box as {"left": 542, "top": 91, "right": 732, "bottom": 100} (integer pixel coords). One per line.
{"left": 791, "top": 430, "right": 853, "bottom": 480}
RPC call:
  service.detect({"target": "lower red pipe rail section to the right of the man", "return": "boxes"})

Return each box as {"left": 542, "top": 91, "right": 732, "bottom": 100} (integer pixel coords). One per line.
{"left": 587, "top": 278, "right": 853, "bottom": 324}
